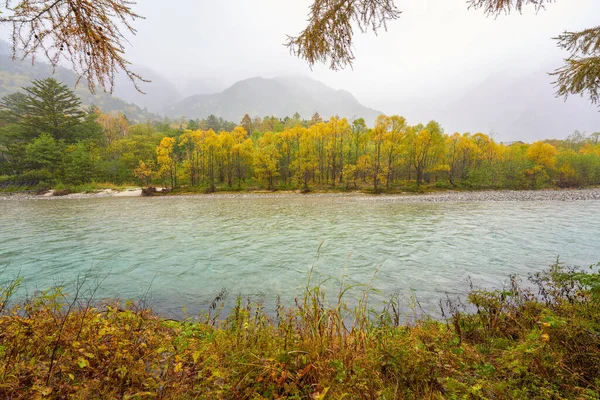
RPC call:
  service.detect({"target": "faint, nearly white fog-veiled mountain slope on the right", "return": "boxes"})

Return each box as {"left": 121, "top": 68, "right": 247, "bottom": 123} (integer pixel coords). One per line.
{"left": 439, "top": 69, "right": 600, "bottom": 141}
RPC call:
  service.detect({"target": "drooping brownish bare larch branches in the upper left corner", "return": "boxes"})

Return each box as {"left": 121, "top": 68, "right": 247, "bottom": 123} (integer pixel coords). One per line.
{"left": 0, "top": 0, "right": 146, "bottom": 93}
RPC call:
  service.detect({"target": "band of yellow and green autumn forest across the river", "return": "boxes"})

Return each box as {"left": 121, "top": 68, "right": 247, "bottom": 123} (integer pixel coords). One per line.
{"left": 0, "top": 78, "right": 600, "bottom": 193}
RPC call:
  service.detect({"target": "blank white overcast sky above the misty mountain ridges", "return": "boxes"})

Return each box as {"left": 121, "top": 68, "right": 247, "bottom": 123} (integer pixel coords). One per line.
{"left": 128, "top": 0, "right": 600, "bottom": 107}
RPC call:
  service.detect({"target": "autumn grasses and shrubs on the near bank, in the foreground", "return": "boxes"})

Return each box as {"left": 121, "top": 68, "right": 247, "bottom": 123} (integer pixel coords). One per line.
{"left": 0, "top": 263, "right": 600, "bottom": 399}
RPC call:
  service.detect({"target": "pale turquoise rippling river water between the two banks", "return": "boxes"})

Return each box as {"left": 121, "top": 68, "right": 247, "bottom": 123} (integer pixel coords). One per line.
{"left": 0, "top": 196, "right": 600, "bottom": 313}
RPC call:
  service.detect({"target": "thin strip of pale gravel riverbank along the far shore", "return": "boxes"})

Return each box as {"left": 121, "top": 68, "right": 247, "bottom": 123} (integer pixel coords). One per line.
{"left": 0, "top": 188, "right": 600, "bottom": 203}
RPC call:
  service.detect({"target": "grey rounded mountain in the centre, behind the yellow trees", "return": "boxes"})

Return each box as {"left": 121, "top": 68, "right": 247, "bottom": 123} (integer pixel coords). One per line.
{"left": 166, "top": 77, "right": 381, "bottom": 125}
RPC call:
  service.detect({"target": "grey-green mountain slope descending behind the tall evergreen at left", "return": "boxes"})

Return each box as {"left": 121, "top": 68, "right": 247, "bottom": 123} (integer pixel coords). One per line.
{"left": 0, "top": 41, "right": 160, "bottom": 122}
